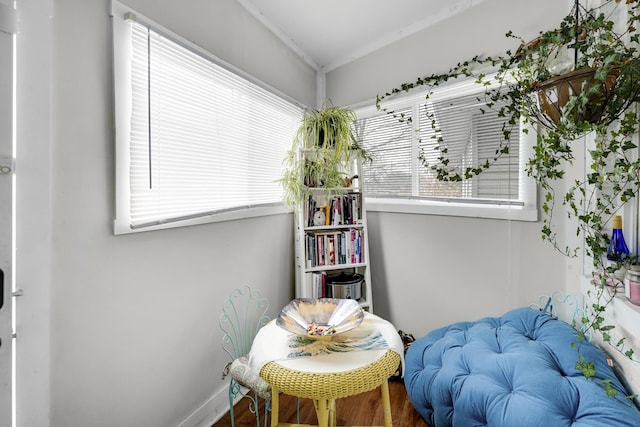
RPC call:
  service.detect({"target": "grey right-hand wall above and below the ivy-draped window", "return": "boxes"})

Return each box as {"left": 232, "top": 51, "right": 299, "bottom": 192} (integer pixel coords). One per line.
{"left": 327, "top": 0, "right": 578, "bottom": 336}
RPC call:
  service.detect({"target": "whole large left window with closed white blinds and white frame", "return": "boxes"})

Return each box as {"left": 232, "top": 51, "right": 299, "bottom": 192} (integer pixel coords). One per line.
{"left": 114, "top": 5, "right": 302, "bottom": 234}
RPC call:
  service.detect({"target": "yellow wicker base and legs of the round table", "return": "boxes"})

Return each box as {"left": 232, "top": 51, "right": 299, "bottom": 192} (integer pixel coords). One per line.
{"left": 260, "top": 350, "right": 401, "bottom": 427}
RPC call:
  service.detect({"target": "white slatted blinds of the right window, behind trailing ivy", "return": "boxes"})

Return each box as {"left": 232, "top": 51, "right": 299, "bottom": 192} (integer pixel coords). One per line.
{"left": 356, "top": 84, "right": 525, "bottom": 205}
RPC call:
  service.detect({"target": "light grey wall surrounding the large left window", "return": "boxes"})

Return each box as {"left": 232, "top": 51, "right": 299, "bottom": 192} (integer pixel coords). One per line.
{"left": 25, "top": 0, "right": 315, "bottom": 427}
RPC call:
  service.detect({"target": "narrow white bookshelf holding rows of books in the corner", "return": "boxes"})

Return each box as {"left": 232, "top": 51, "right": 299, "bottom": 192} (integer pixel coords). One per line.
{"left": 294, "top": 149, "right": 373, "bottom": 312}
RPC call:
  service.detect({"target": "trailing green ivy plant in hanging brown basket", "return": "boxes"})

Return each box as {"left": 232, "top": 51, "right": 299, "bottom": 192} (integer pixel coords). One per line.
{"left": 376, "top": 0, "right": 640, "bottom": 394}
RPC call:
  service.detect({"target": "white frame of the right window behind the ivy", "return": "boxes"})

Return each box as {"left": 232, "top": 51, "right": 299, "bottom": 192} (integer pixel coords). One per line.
{"left": 352, "top": 79, "right": 538, "bottom": 221}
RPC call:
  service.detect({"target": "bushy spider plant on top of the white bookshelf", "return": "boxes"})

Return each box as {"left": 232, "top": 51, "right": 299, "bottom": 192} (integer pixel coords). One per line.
{"left": 280, "top": 101, "right": 367, "bottom": 207}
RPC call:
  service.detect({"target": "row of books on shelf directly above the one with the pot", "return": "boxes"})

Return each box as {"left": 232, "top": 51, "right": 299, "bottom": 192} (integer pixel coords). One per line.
{"left": 305, "top": 228, "right": 365, "bottom": 268}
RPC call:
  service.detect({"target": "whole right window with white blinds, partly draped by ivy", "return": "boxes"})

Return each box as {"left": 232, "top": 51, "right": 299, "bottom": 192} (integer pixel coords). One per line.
{"left": 355, "top": 78, "right": 537, "bottom": 221}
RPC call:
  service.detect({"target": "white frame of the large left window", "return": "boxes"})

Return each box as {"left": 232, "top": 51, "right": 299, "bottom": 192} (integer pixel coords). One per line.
{"left": 111, "top": 1, "right": 306, "bottom": 235}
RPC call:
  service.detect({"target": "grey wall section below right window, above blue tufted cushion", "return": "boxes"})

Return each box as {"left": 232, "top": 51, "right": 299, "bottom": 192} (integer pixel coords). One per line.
{"left": 368, "top": 212, "right": 566, "bottom": 337}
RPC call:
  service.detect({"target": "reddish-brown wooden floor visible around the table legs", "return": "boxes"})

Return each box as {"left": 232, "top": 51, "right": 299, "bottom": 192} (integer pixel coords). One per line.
{"left": 212, "top": 381, "right": 428, "bottom": 427}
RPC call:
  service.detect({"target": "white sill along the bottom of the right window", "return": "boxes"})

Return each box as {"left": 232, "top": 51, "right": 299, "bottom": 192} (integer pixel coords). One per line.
{"left": 367, "top": 198, "right": 538, "bottom": 221}
